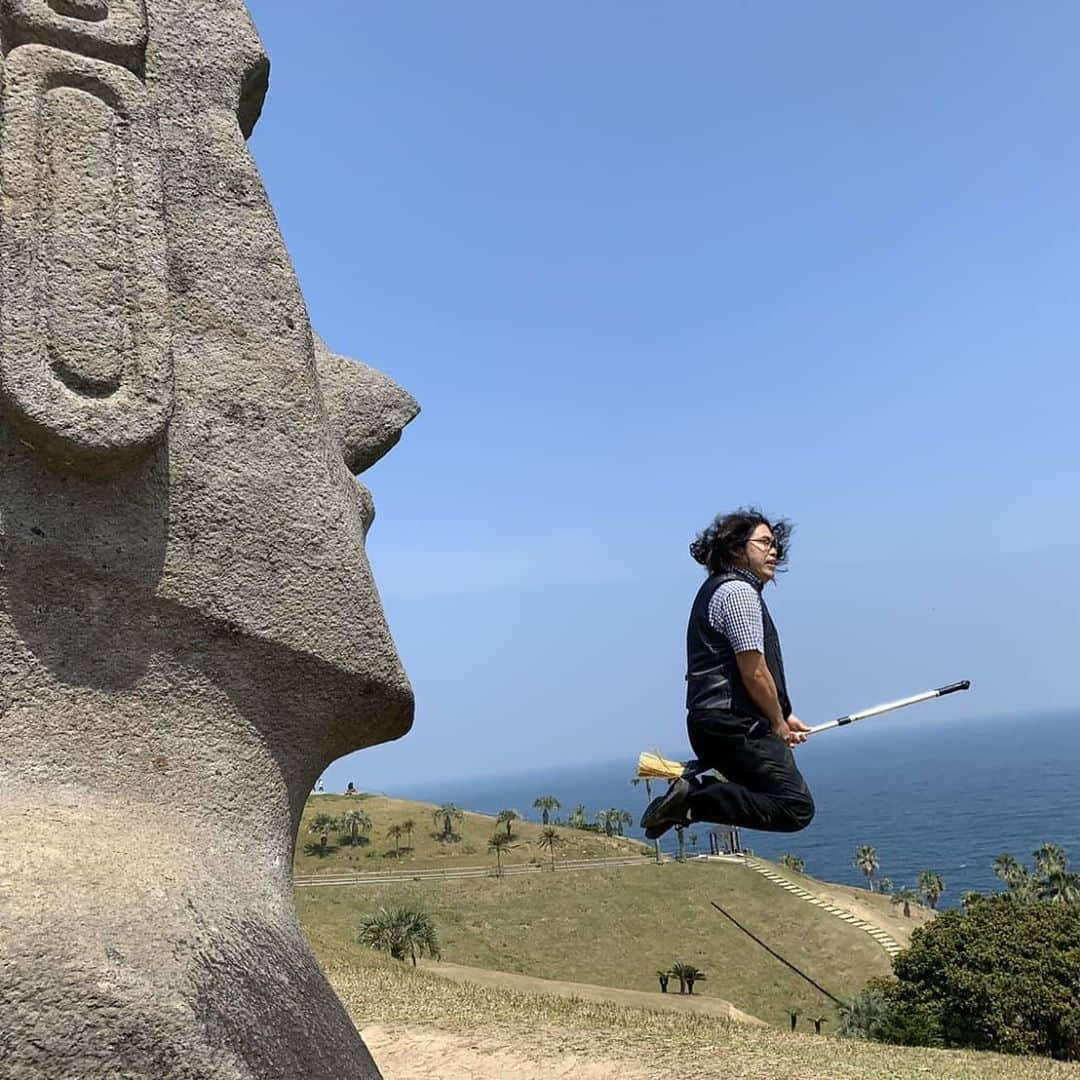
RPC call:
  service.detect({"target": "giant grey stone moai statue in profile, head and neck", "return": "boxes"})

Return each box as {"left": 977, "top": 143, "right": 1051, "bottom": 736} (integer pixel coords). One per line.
{"left": 0, "top": 0, "right": 417, "bottom": 1080}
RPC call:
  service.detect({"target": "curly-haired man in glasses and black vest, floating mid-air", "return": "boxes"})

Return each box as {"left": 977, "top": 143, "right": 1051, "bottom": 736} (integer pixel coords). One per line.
{"left": 642, "top": 509, "right": 814, "bottom": 839}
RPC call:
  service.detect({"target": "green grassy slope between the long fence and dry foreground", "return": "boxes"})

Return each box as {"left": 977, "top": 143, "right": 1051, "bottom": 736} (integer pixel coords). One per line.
{"left": 297, "top": 846, "right": 891, "bottom": 1026}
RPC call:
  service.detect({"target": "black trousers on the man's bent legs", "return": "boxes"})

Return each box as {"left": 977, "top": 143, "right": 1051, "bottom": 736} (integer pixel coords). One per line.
{"left": 687, "top": 713, "right": 814, "bottom": 833}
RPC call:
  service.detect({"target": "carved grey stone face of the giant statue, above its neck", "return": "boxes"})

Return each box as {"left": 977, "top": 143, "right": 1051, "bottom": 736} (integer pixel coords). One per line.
{"left": 0, "top": 0, "right": 417, "bottom": 777}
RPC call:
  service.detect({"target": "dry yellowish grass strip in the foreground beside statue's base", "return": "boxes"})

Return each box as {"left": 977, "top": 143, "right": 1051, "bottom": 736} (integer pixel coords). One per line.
{"left": 323, "top": 951, "right": 1080, "bottom": 1080}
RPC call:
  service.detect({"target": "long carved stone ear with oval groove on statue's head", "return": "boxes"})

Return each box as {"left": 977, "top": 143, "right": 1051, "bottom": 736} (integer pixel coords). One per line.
{"left": 0, "top": 45, "right": 173, "bottom": 462}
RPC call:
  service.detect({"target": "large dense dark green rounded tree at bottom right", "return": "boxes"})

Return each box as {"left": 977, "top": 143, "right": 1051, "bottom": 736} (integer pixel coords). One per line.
{"left": 872, "top": 893, "right": 1080, "bottom": 1061}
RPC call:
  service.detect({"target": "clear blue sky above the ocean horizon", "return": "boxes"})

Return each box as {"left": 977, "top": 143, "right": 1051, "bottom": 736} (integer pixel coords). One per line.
{"left": 249, "top": 0, "right": 1080, "bottom": 789}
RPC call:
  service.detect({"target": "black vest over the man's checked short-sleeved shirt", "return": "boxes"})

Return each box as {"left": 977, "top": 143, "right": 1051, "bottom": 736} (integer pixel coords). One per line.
{"left": 686, "top": 570, "right": 792, "bottom": 723}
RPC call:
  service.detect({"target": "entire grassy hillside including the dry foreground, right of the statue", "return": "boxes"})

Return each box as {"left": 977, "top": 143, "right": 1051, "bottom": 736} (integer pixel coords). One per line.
{"left": 296, "top": 796, "right": 1080, "bottom": 1080}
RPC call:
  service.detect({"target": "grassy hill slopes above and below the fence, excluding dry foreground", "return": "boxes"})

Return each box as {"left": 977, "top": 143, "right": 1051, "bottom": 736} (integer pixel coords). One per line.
{"left": 296, "top": 796, "right": 906, "bottom": 1026}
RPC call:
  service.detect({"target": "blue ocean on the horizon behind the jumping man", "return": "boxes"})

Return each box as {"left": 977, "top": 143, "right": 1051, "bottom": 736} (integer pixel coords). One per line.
{"left": 394, "top": 710, "right": 1080, "bottom": 907}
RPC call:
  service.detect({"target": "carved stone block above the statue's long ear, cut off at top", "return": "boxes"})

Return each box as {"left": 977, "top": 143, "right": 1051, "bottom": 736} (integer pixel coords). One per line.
{"left": 0, "top": 0, "right": 147, "bottom": 75}
